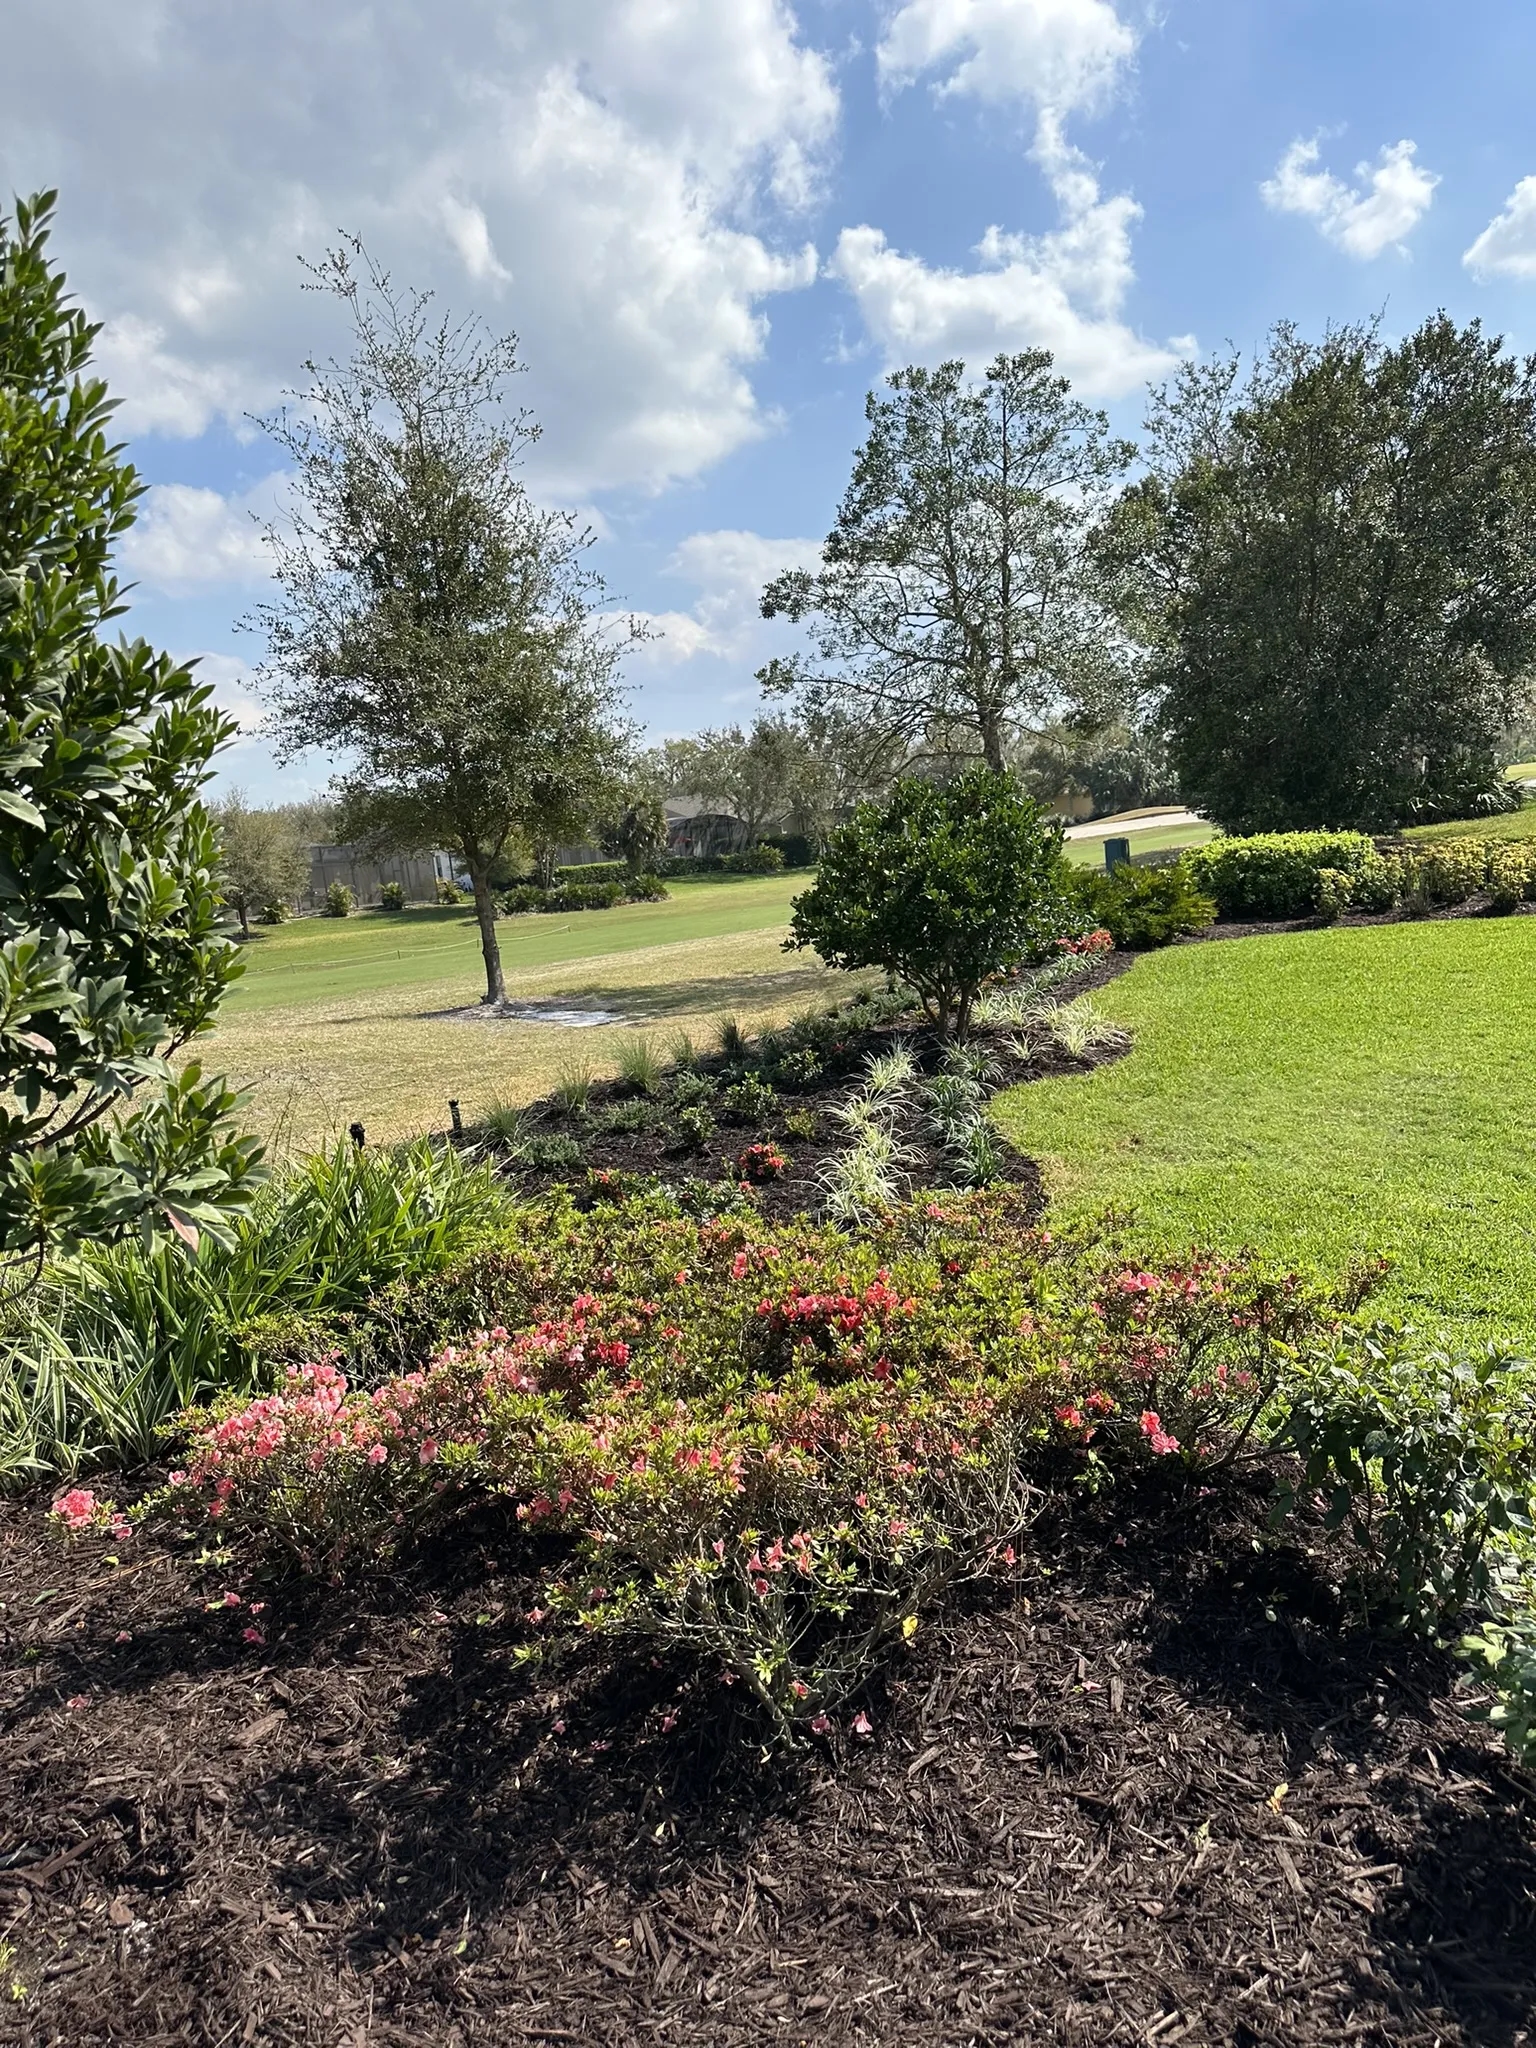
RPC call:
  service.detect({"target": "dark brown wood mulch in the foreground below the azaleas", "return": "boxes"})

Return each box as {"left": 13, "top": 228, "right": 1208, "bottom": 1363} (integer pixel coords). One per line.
{"left": 0, "top": 1489, "right": 1536, "bottom": 2048}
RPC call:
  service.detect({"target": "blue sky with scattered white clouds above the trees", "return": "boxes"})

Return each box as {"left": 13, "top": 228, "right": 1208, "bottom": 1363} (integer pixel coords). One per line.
{"left": 0, "top": 0, "right": 1536, "bottom": 799}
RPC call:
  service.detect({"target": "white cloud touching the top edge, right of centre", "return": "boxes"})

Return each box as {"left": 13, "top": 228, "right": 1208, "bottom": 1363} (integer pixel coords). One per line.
{"left": 879, "top": 0, "right": 1137, "bottom": 113}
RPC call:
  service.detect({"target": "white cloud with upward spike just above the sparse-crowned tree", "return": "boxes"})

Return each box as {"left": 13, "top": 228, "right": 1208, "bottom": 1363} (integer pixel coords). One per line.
{"left": 831, "top": 111, "right": 1188, "bottom": 397}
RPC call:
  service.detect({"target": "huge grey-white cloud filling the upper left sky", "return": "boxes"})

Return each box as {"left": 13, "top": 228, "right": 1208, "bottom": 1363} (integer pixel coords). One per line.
{"left": 0, "top": 0, "right": 838, "bottom": 496}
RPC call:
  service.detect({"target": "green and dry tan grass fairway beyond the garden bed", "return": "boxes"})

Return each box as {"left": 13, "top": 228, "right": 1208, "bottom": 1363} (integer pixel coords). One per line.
{"left": 193, "top": 874, "right": 856, "bottom": 1155}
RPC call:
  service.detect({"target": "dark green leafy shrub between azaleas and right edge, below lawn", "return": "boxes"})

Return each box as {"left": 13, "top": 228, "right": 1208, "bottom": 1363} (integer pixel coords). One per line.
{"left": 1278, "top": 1333, "right": 1536, "bottom": 1630}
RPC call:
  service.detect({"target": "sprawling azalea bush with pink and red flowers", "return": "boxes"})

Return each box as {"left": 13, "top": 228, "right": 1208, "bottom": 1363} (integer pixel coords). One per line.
{"left": 152, "top": 1188, "right": 1368, "bottom": 1729}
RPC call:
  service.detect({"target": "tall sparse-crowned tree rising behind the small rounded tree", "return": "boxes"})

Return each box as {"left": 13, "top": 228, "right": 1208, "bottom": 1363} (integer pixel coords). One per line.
{"left": 760, "top": 350, "right": 1133, "bottom": 770}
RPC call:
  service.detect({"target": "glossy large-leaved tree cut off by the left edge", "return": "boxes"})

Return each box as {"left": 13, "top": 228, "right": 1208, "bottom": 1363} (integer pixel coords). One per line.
{"left": 0, "top": 193, "right": 260, "bottom": 1272}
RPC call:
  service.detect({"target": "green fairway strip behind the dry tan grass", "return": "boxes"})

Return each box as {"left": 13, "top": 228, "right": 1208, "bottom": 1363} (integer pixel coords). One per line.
{"left": 225, "top": 874, "right": 811, "bottom": 1018}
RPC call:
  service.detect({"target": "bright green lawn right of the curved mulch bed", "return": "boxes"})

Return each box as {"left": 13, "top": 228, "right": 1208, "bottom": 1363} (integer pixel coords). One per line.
{"left": 997, "top": 918, "right": 1536, "bottom": 1343}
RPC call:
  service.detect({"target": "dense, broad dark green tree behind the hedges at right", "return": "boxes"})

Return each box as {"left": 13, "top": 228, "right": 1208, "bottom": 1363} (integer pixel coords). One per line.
{"left": 1100, "top": 315, "right": 1536, "bottom": 831}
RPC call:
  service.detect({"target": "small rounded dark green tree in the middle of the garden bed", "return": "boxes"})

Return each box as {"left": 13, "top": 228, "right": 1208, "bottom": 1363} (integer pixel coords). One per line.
{"left": 784, "top": 768, "right": 1085, "bottom": 1038}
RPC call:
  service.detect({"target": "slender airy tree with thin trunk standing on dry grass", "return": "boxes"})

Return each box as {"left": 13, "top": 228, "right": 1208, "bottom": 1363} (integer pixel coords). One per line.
{"left": 258, "top": 242, "right": 633, "bottom": 1004}
